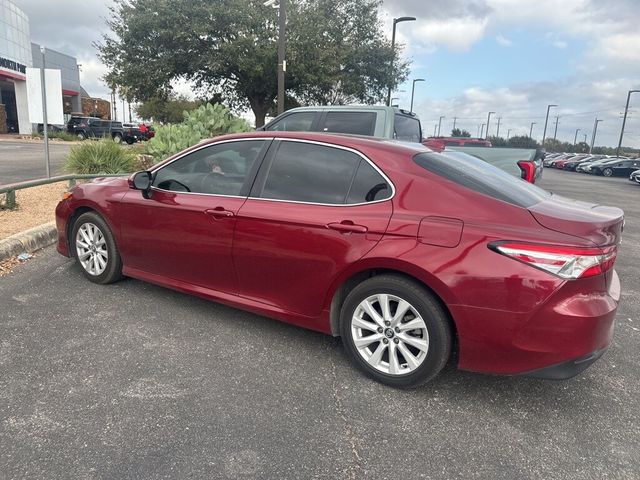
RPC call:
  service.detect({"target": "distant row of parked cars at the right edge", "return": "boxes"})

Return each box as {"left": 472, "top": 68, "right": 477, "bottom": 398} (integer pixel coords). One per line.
{"left": 544, "top": 153, "right": 640, "bottom": 181}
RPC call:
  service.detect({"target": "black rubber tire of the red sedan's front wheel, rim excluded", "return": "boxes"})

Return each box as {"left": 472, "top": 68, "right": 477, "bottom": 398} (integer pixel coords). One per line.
{"left": 69, "top": 212, "right": 122, "bottom": 285}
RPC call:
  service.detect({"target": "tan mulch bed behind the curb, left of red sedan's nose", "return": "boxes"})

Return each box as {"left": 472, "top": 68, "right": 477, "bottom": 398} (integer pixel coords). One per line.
{"left": 0, "top": 182, "right": 67, "bottom": 240}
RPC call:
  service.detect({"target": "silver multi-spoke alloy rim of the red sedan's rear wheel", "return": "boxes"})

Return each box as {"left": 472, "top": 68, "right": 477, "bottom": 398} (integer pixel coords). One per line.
{"left": 351, "top": 294, "right": 429, "bottom": 376}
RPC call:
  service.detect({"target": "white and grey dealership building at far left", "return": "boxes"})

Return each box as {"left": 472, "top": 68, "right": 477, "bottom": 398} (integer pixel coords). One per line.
{"left": 0, "top": 0, "right": 94, "bottom": 134}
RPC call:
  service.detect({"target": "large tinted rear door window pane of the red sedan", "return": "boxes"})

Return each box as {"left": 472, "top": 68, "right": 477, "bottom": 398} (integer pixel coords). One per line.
{"left": 260, "top": 142, "right": 361, "bottom": 204}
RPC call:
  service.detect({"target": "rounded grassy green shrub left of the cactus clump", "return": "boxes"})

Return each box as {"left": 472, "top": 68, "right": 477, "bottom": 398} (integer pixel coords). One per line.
{"left": 64, "top": 139, "right": 137, "bottom": 174}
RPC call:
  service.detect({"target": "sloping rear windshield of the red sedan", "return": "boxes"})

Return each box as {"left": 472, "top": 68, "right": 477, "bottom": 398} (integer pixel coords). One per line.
{"left": 413, "top": 152, "right": 551, "bottom": 208}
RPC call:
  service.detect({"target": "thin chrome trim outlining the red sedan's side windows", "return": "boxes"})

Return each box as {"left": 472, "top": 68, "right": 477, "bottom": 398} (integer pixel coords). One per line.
{"left": 150, "top": 137, "right": 396, "bottom": 207}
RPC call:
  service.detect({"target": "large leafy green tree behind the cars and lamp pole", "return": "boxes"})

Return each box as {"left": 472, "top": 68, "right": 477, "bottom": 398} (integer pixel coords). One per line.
{"left": 97, "top": 0, "right": 408, "bottom": 126}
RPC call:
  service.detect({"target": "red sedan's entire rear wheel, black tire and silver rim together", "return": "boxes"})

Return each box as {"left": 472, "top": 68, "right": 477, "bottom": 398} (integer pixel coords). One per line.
{"left": 340, "top": 275, "right": 452, "bottom": 387}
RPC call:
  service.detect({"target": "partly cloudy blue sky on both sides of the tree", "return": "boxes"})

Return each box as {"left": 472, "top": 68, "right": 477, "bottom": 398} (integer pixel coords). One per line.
{"left": 14, "top": 0, "right": 640, "bottom": 147}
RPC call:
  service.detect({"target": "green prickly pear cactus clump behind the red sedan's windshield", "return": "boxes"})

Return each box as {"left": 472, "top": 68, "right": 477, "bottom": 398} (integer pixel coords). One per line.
{"left": 146, "top": 103, "right": 251, "bottom": 162}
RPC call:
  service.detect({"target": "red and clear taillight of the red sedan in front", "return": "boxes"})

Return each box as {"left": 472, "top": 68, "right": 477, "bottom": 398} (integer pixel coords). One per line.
{"left": 489, "top": 242, "right": 618, "bottom": 280}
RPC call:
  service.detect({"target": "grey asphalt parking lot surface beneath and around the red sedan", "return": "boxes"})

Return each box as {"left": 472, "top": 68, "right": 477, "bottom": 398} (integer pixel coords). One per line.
{"left": 0, "top": 170, "right": 640, "bottom": 479}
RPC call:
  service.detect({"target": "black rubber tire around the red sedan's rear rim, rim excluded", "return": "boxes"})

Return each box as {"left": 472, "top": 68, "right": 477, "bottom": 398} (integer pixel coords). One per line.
{"left": 340, "top": 275, "right": 453, "bottom": 388}
